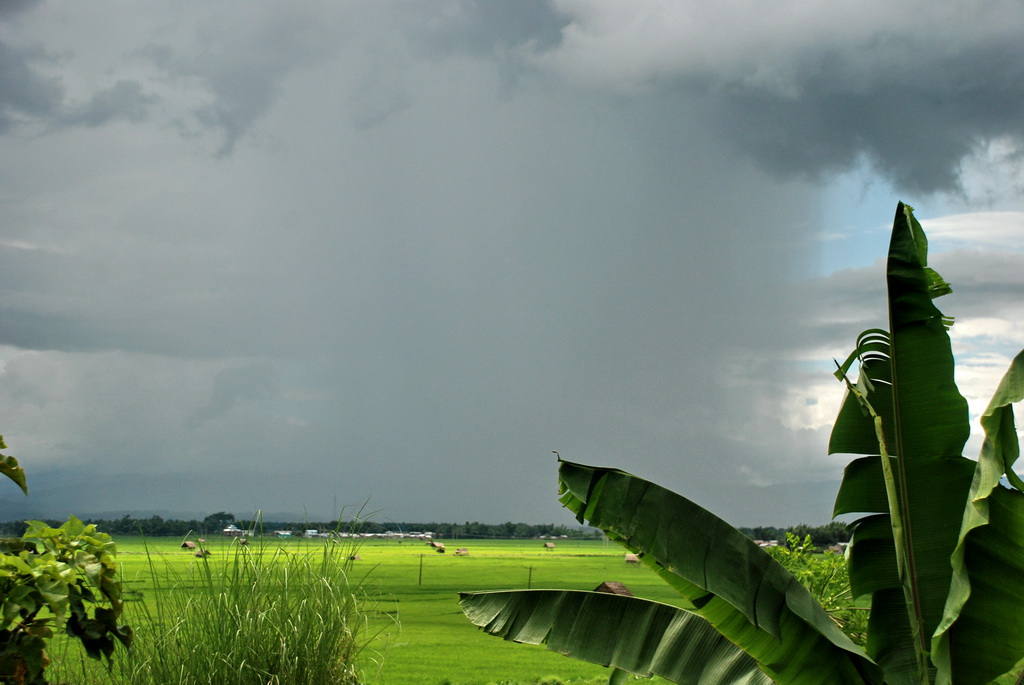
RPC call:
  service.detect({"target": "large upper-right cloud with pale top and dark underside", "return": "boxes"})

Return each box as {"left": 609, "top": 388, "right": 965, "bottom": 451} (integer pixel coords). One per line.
{"left": 534, "top": 1, "right": 1024, "bottom": 192}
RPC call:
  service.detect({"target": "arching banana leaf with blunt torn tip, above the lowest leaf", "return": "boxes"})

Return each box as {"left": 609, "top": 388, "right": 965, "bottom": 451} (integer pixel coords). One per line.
{"left": 558, "top": 461, "right": 882, "bottom": 683}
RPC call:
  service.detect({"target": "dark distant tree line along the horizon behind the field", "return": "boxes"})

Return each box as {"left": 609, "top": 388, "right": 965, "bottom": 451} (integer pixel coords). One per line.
{"left": 0, "top": 511, "right": 850, "bottom": 548}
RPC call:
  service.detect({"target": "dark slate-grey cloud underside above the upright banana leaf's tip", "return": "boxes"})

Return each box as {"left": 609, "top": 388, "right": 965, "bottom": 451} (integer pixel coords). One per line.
{"left": 710, "top": 40, "right": 1024, "bottom": 192}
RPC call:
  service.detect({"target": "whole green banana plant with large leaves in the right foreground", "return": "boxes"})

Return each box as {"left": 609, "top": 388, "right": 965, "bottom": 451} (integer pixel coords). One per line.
{"left": 460, "top": 203, "right": 1024, "bottom": 685}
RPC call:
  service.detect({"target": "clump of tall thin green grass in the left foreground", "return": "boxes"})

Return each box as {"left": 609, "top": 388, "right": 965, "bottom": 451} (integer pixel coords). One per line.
{"left": 113, "top": 540, "right": 370, "bottom": 685}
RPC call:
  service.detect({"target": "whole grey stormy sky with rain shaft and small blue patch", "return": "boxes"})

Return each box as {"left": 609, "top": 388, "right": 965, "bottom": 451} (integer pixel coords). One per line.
{"left": 0, "top": 0, "right": 1024, "bottom": 525}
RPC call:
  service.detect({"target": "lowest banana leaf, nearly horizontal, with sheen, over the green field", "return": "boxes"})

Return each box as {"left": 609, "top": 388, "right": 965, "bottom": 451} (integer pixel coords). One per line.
{"left": 460, "top": 590, "right": 772, "bottom": 685}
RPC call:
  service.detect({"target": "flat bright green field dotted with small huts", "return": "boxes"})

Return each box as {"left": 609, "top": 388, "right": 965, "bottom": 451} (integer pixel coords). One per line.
{"left": 58, "top": 537, "right": 674, "bottom": 685}
